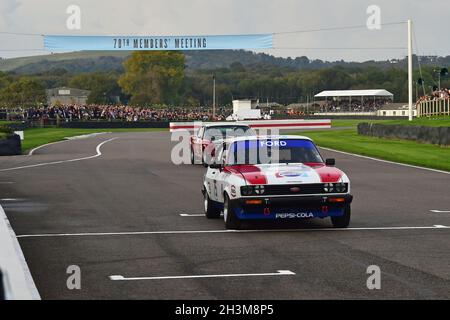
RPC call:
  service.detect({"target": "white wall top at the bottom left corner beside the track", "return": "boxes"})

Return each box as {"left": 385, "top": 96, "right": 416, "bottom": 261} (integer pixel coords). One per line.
{"left": 0, "top": 206, "right": 40, "bottom": 300}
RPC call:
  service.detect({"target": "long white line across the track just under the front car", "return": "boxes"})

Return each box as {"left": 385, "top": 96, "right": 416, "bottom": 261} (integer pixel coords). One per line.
{"left": 17, "top": 225, "right": 450, "bottom": 238}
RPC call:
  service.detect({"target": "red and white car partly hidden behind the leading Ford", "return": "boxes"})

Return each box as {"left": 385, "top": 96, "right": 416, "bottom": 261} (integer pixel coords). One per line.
{"left": 190, "top": 124, "right": 256, "bottom": 164}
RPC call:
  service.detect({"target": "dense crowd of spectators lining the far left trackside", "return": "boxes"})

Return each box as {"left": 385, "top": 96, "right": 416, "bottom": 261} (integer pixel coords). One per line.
{"left": 3, "top": 105, "right": 229, "bottom": 122}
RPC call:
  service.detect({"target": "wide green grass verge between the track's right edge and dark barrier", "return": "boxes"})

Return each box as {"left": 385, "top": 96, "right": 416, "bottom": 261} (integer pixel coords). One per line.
{"left": 299, "top": 129, "right": 450, "bottom": 171}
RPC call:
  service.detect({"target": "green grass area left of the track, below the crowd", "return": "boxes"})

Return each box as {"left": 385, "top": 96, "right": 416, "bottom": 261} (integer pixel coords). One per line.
{"left": 22, "top": 127, "right": 168, "bottom": 153}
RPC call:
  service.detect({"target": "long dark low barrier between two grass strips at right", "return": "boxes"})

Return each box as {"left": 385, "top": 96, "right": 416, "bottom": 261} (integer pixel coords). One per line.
{"left": 358, "top": 122, "right": 450, "bottom": 146}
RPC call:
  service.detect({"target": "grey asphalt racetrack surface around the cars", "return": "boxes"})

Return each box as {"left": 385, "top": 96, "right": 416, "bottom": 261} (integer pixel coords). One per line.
{"left": 0, "top": 132, "right": 450, "bottom": 299}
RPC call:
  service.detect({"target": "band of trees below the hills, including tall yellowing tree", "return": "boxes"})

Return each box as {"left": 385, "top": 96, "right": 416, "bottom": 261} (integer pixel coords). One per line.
{"left": 0, "top": 51, "right": 450, "bottom": 107}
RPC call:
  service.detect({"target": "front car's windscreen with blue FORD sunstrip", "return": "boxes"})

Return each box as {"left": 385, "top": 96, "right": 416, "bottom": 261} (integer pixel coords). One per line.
{"left": 227, "top": 139, "right": 323, "bottom": 165}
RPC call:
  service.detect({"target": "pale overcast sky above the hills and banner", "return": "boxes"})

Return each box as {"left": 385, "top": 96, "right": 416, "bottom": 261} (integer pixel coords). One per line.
{"left": 0, "top": 0, "right": 450, "bottom": 61}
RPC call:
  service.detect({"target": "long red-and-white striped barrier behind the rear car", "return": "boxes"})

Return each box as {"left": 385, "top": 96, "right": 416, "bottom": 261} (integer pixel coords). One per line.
{"left": 169, "top": 119, "right": 331, "bottom": 132}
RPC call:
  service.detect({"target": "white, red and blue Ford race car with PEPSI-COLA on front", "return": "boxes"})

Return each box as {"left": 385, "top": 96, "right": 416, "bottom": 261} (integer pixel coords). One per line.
{"left": 202, "top": 136, "right": 353, "bottom": 229}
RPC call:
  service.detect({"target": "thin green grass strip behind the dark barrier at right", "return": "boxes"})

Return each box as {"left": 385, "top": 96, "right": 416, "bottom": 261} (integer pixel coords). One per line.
{"left": 331, "top": 117, "right": 450, "bottom": 128}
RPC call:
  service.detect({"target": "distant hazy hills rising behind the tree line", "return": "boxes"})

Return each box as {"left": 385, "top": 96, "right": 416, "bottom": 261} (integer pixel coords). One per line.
{"left": 0, "top": 50, "right": 450, "bottom": 74}
